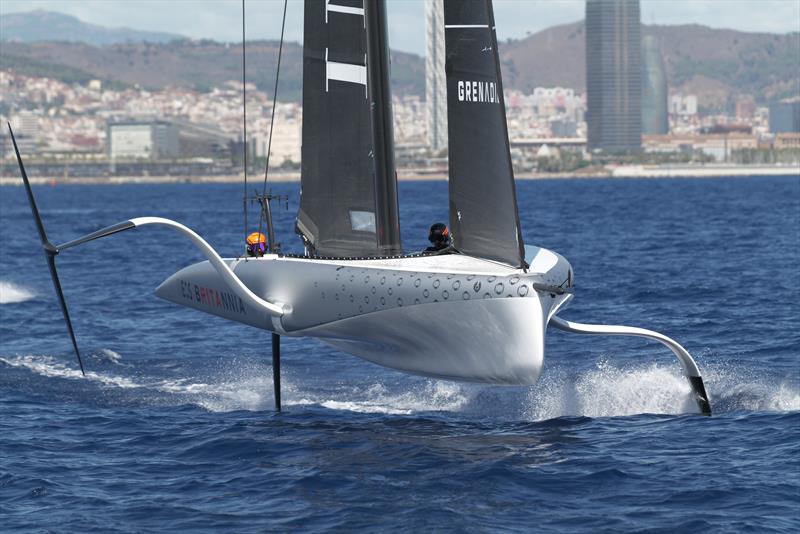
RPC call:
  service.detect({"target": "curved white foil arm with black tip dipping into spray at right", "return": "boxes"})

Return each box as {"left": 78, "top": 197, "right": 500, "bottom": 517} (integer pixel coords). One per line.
{"left": 550, "top": 316, "right": 711, "bottom": 415}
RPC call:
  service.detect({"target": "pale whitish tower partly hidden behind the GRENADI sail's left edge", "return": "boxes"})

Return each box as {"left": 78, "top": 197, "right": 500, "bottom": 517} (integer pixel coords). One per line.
{"left": 425, "top": 0, "right": 447, "bottom": 151}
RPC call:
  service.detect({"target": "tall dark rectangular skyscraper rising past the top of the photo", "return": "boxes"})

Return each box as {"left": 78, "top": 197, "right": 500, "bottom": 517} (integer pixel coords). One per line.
{"left": 586, "top": 0, "right": 642, "bottom": 152}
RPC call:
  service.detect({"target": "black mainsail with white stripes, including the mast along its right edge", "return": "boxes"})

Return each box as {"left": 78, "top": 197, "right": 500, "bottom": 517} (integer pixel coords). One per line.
{"left": 297, "top": 0, "right": 401, "bottom": 257}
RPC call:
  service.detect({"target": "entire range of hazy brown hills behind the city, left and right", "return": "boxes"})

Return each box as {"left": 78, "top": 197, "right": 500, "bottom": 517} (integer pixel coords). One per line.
{"left": 0, "top": 16, "right": 800, "bottom": 110}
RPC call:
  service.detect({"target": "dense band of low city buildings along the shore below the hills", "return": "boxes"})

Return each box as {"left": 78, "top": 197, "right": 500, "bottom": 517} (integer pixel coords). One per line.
{"left": 0, "top": 69, "right": 800, "bottom": 177}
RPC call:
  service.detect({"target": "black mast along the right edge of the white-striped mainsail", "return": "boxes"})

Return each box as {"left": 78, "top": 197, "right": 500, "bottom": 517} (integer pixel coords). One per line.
{"left": 364, "top": 0, "right": 402, "bottom": 256}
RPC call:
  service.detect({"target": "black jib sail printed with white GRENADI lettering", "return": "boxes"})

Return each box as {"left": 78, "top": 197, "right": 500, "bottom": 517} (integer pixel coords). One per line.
{"left": 444, "top": 0, "right": 526, "bottom": 267}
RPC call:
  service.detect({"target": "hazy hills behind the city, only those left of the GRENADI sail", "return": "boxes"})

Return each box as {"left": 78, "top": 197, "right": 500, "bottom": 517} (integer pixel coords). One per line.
{"left": 0, "top": 40, "right": 425, "bottom": 100}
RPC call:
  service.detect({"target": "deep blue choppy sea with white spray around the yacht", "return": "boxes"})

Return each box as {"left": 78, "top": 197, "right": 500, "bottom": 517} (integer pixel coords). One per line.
{"left": 0, "top": 178, "right": 800, "bottom": 533}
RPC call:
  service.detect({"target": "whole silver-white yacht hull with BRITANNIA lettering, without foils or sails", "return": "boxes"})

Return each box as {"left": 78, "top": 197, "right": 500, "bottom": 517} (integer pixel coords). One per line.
{"left": 156, "top": 247, "right": 572, "bottom": 384}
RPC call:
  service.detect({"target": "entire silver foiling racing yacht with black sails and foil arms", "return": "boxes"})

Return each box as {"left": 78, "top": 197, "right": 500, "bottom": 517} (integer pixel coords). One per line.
{"left": 9, "top": 0, "right": 711, "bottom": 414}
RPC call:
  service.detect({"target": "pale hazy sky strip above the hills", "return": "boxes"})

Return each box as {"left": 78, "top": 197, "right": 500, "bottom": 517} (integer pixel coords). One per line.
{"left": 0, "top": 0, "right": 800, "bottom": 54}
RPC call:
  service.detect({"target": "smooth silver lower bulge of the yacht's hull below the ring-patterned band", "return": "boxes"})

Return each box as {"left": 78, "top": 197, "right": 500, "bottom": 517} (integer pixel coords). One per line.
{"left": 303, "top": 296, "right": 564, "bottom": 385}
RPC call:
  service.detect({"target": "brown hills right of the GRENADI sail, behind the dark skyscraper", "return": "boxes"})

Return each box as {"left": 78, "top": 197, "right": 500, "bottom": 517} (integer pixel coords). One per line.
{"left": 500, "top": 21, "right": 800, "bottom": 109}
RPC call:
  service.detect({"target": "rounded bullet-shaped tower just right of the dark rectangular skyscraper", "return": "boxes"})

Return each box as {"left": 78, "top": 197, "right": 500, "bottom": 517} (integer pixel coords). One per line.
{"left": 642, "top": 35, "right": 669, "bottom": 135}
